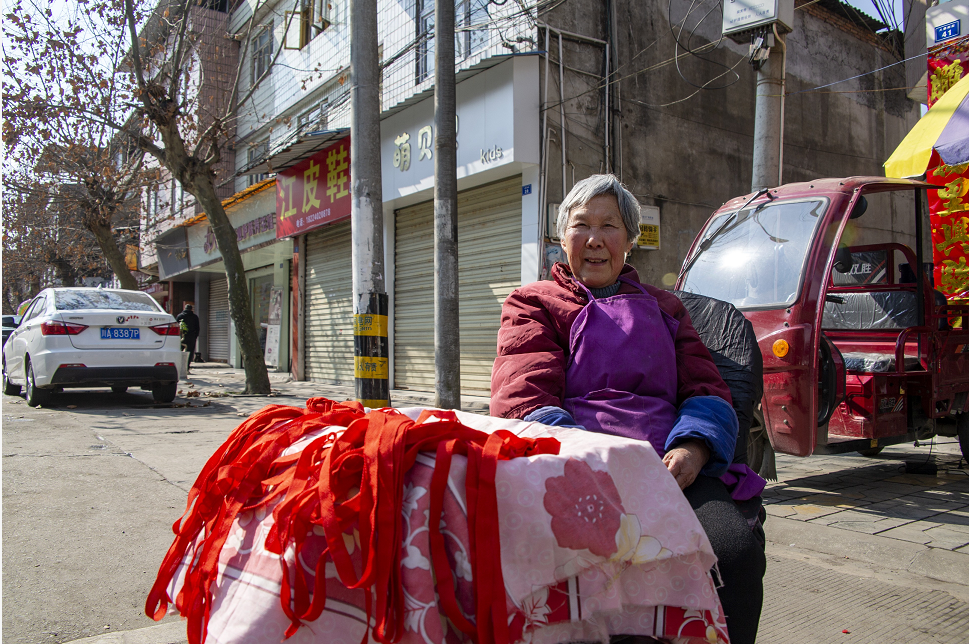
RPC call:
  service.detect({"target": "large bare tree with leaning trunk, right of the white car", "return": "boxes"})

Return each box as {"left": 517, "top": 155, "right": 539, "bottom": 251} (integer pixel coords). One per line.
{"left": 4, "top": 0, "right": 298, "bottom": 393}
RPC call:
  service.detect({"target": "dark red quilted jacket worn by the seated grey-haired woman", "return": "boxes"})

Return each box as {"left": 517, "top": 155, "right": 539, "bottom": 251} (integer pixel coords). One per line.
{"left": 491, "top": 263, "right": 731, "bottom": 418}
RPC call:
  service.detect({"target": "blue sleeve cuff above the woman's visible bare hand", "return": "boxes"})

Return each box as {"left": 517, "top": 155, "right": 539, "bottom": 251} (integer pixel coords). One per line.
{"left": 666, "top": 396, "right": 739, "bottom": 477}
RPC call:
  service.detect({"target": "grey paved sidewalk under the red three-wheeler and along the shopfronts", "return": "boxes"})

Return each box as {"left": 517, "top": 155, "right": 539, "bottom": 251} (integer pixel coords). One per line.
{"left": 73, "top": 363, "right": 969, "bottom": 644}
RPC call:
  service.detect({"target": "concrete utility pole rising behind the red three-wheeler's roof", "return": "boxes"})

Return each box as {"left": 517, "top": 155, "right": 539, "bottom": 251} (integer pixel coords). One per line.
{"left": 750, "top": 27, "right": 787, "bottom": 191}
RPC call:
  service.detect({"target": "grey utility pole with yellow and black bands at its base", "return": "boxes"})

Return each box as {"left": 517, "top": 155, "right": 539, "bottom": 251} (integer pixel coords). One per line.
{"left": 350, "top": 0, "right": 390, "bottom": 407}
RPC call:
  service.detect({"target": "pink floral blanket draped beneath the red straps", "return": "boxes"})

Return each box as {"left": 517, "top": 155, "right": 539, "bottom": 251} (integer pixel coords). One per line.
{"left": 169, "top": 408, "right": 728, "bottom": 644}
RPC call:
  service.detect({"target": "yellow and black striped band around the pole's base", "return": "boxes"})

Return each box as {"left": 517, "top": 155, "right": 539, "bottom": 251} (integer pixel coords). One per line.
{"left": 353, "top": 293, "right": 390, "bottom": 408}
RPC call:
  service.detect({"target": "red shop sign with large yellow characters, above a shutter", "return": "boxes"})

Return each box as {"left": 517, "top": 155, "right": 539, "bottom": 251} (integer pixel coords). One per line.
{"left": 276, "top": 137, "right": 352, "bottom": 239}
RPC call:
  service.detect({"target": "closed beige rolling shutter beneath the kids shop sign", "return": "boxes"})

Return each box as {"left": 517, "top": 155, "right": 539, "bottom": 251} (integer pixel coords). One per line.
{"left": 394, "top": 176, "right": 522, "bottom": 395}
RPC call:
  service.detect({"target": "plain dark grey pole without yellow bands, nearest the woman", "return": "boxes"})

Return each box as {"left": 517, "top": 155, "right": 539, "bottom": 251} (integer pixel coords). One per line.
{"left": 434, "top": 0, "right": 461, "bottom": 409}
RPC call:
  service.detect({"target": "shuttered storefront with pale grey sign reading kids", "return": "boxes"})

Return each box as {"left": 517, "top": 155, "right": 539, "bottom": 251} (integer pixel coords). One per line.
{"left": 381, "top": 57, "right": 539, "bottom": 395}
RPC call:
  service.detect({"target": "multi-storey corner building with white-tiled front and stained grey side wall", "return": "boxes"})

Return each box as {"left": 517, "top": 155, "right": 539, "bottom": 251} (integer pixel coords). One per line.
{"left": 138, "top": 0, "right": 919, "bottom": 394}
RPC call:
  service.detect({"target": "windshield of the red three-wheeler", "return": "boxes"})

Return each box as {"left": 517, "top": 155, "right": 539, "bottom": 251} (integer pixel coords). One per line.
{"left": 683, "top": 200, "right": 827, "bottom": 309}
